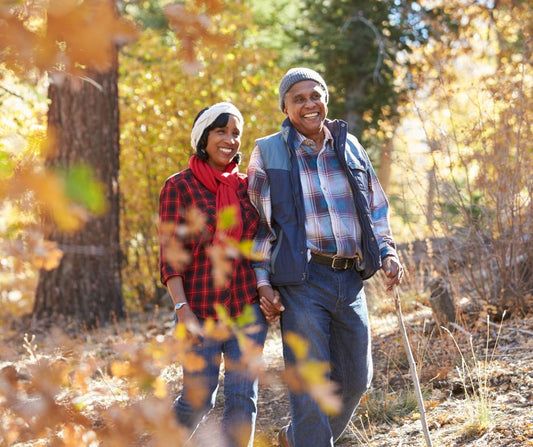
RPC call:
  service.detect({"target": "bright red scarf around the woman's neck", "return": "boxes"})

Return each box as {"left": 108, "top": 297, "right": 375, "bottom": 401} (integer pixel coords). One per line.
{"left": 189, "top": 155, "right": 242, "bottom": 241}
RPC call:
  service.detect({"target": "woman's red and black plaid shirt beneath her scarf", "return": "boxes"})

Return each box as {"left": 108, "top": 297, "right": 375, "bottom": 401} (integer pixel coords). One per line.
{"left": 159, "top": 169, "right": 259, "bottom": 318}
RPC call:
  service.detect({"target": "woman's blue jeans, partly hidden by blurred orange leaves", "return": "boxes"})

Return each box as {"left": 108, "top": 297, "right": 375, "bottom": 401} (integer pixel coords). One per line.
{"left": 173, "top": 304, "right": 268, "bottom": 447}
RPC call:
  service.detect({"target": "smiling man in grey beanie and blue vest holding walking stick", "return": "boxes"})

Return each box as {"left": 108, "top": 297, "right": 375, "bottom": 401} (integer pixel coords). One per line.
{"left": 248, "top": 68, "right": 403, "bottom": 447}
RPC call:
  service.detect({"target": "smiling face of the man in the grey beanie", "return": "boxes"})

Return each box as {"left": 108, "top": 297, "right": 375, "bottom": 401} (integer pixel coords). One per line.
{"left": 283, "top": 80, "right": 328, "bottom": 139}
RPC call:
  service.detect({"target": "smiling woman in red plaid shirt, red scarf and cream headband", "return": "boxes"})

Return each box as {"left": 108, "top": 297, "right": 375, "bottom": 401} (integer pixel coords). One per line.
{"left": 159, "top": 102, "right": 267, "bottom": 447}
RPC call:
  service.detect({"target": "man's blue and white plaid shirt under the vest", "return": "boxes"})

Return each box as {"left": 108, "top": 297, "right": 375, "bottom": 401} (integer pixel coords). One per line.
{"left": 248, "top": 126, "right": 392, "bottom": 287}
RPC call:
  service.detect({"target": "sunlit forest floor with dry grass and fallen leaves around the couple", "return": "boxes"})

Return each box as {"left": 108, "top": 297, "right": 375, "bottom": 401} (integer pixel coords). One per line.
{"left": 0, "top": 298, "right": 533, "bottom": 447}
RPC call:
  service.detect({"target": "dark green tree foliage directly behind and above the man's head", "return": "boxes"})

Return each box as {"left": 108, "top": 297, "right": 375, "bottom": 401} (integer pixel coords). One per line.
{"left": 288, "top": 0, "right": 450, "bottom": 143}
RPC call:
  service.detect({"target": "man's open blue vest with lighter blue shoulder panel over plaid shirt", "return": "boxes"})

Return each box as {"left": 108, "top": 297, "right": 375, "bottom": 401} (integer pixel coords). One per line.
{"left": 256, "top": 119, "right": 381, "bottom": 286}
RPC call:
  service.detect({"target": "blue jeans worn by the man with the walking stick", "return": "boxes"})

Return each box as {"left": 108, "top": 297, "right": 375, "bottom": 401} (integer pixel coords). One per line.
{"left": 279, "top": 262, "right": 372, "bottom": 447}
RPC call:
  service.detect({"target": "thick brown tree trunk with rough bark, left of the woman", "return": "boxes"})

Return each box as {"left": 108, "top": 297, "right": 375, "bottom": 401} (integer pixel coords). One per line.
{"left": 33, "top": 61, "right": 125, "bottom": 327}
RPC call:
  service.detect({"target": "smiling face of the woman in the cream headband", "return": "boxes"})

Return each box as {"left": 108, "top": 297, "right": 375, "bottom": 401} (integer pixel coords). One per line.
{"left": 205, "top": 115, "right": 241, "bottom": 171}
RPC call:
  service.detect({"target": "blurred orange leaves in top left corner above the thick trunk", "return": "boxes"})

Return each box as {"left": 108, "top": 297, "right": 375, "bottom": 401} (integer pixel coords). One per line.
{"left": 0, "top": 0, "right": 138, "bottom": 75}
